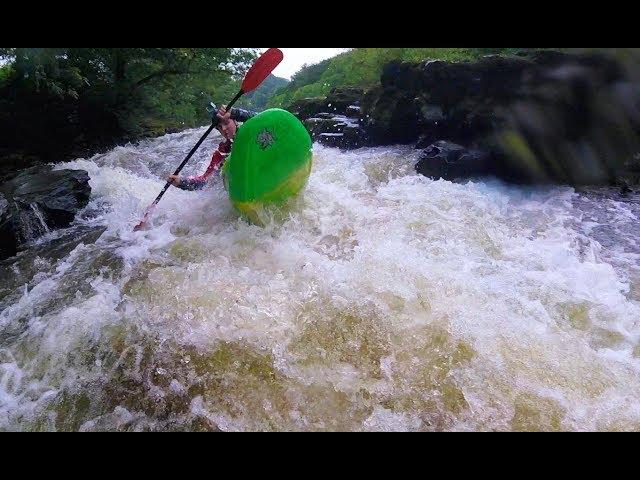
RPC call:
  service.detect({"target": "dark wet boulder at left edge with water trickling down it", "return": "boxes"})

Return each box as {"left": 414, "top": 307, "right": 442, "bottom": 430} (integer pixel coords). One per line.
{"left": 0, "top": 166, "right": 91, "bottom": 258}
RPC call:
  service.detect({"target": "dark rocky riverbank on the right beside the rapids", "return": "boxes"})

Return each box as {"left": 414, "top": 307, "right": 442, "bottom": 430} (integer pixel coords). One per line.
{"left": 291, "top": 51, "right": 640, "bottom": 187}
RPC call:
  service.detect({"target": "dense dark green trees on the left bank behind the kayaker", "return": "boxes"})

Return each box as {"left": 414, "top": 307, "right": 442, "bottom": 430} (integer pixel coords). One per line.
{"left": 0, "top": 48, "right": 286, "bottom": 173}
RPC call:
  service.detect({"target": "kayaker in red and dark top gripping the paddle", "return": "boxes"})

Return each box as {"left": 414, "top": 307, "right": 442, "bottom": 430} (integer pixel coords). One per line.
{"left": 167, "top": 104, "right": 256, "bottom": 190}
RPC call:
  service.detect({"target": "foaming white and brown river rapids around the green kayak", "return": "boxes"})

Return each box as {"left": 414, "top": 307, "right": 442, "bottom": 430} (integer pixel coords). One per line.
{"left": 0, "top": 129, "right": 640, "bottom": 431}
